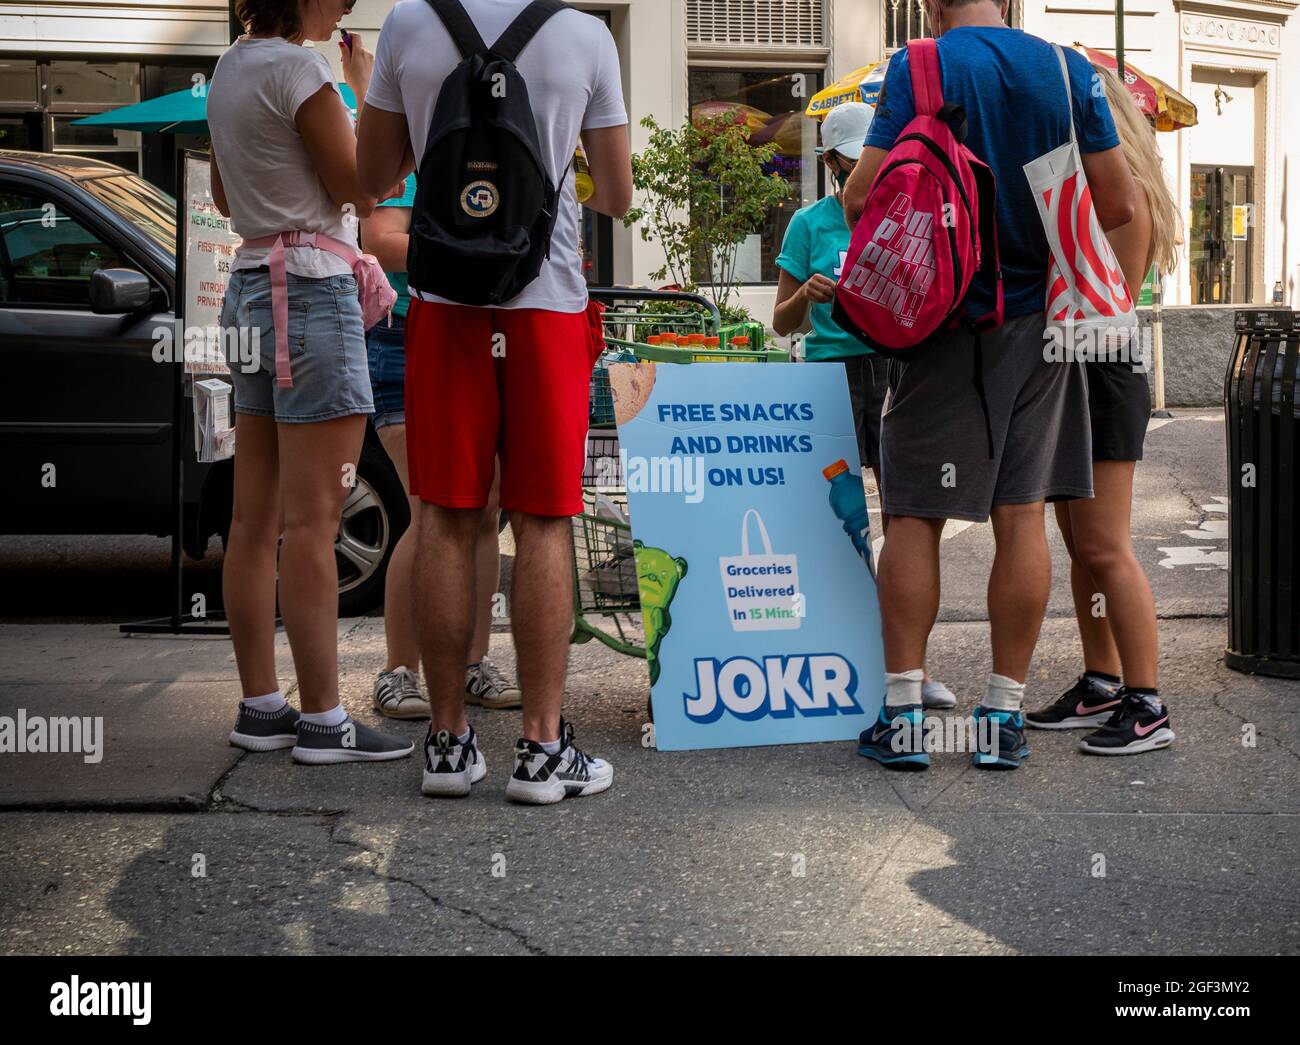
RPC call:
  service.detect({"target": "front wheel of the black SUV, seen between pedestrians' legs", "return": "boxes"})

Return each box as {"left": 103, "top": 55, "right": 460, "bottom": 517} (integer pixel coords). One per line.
{"left": 334, "top": 439, "right": 411, "bottom": 617}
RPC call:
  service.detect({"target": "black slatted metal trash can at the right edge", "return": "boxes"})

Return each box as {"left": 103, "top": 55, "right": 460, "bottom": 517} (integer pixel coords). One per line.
{"left": 1223, "top": 309, "right": 1300, "bottom": 678}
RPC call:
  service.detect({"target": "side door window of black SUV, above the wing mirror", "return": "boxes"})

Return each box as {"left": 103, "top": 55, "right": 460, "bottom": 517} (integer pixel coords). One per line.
{"left": 0, "top": 182, "right": 124, "bottom": 308}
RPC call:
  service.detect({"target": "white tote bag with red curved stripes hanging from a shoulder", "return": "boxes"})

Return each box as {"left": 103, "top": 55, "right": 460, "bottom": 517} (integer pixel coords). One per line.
{"left": 1024, "top": 44, "right": 1138, "bottom": 337}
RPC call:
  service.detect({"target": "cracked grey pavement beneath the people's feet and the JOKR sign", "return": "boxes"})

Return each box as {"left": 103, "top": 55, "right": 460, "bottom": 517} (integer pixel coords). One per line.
{"left": 0, "top": 413, "right": 1300, "bottom": 954}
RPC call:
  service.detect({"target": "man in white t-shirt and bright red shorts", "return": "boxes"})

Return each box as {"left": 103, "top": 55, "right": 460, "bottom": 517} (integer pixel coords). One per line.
{"left": 358, "top": 0, "right": 632, "bottom": 803}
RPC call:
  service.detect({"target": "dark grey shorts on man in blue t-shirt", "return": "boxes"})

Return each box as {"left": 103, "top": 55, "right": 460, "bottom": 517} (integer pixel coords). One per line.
{"left": 880, "top": 312, "right": 1092, "bottom": 523}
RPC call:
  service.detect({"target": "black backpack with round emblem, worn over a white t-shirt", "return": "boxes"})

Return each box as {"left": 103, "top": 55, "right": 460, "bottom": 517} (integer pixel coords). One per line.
{"left": 407, "top": 0, "right": 568, "bottom": 305}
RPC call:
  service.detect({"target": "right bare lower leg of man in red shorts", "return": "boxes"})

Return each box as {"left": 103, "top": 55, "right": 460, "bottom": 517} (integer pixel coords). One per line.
{"left": 510, "top": 511, "right": 573, "bottom": 742}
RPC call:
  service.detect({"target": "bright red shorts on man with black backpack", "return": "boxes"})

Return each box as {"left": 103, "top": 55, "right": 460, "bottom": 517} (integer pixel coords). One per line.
{"left": 406, "top": 296, "right": 605, "bottom": 516}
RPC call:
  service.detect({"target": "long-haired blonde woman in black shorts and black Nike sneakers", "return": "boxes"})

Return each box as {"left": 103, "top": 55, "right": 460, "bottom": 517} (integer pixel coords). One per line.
{"left": 1024, "top": 66, "right": 1179, "bottom": 755}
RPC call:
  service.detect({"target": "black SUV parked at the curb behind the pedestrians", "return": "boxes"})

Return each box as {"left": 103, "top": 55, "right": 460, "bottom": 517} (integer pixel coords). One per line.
{"left": 0, "top": 151, "right": 410, "bottom": 616}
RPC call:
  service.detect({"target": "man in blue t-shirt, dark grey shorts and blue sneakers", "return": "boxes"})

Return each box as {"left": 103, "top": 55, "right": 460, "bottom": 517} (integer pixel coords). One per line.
{"left": 844, "top": 0, "right": 1136, "bottom": 768}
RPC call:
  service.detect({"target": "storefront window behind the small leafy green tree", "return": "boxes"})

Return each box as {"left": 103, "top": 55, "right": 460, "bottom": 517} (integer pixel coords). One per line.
{"left": 689, "top": 65, "right": 822, "bottom": 283}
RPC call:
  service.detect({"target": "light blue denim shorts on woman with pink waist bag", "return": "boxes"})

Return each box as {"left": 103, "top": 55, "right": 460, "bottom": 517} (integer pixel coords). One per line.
{"left": 221, "top": 269, "right": 374, "bottom": 424}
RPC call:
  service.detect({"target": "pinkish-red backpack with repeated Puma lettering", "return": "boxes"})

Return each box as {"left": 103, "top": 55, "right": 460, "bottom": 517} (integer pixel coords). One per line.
{"left": 832, "top": 39, "right": 1002, "bottom": 355}
